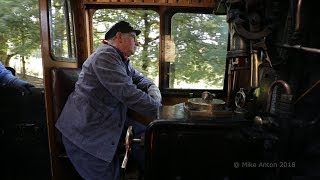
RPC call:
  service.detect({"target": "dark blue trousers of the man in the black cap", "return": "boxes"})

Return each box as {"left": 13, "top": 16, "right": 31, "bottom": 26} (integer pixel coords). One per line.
{"left": 62, "top": 118, "right": 146, "bottom": 180}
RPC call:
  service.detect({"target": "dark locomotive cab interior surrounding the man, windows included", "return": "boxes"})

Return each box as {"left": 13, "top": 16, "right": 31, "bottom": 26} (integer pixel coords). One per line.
{"left": 0, "top": 0, "right": 320, "bottom": 180}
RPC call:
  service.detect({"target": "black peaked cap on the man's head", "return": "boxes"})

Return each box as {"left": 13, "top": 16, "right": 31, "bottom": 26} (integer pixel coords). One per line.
{"left": 104, "top": 21, "right": 141, "bottom": 40}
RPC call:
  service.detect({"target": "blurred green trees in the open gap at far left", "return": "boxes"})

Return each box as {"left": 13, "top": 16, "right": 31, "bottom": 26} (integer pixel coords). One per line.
{"left": 0, "top": 0, "right": 40, "bottom": 76}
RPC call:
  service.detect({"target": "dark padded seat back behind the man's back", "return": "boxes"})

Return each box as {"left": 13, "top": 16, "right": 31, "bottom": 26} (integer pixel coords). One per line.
{"left": 49, "top": 67, "right": 82, "bottom": 180}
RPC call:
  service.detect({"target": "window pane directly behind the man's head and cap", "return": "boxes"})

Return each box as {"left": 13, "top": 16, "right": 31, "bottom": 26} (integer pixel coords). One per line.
{"left": 93, "top": 9, "right": 160, "bottom": 84}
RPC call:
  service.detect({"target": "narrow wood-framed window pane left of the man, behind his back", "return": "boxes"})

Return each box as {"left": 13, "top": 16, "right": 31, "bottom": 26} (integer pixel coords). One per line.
{"left": 50, "top": 0, "right": 76, "bottom": 62}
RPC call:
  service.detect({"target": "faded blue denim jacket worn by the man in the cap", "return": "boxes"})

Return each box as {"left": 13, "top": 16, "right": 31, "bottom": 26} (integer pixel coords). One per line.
{"left": 56, "top": 44, "right": 161, "bottom": 162}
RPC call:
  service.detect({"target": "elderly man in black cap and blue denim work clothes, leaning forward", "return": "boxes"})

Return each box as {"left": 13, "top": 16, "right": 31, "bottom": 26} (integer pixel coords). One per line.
{"left": 56, "top": 21, "right": 161, "bottom": 180}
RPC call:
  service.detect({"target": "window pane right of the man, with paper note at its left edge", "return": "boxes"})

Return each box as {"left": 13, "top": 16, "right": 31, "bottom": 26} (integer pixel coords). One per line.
{"left": 165, "top": 13, "right": 228, "bottom": 89}
